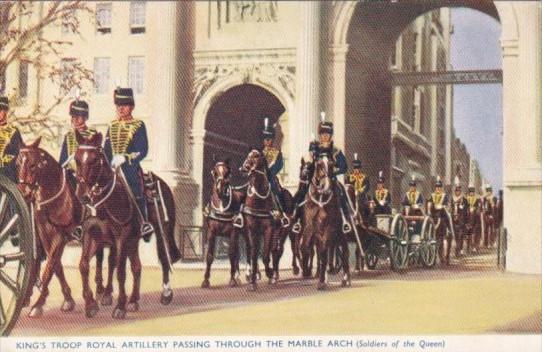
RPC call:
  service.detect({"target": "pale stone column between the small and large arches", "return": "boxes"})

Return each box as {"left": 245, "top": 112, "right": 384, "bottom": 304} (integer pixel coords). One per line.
{"left": 288, "top": 1, "right": 321, "bottom": 182}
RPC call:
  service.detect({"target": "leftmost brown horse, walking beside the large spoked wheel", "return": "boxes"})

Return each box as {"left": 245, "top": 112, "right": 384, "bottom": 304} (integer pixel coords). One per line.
{"left": 15, "top": 138, "right": 82, "bottom": 318}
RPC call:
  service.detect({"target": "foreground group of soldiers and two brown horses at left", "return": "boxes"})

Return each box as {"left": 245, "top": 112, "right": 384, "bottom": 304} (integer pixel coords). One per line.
{"left": 0, "top": 88, "right": 181, "bottom": 319}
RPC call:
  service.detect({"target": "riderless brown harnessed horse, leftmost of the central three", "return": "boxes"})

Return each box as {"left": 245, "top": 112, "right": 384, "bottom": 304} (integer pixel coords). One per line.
{"left": 201, "top": 160, "right": 244, "bottom": 288}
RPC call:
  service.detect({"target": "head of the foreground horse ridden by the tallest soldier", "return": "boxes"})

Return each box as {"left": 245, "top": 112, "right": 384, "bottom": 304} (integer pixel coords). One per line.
{"left": 74, "top": 131, "right": 108, "bottom": 203}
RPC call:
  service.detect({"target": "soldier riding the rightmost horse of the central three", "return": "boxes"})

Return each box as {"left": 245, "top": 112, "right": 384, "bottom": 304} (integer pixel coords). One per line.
{"left": 316, "top": 112, "right": 353, "bottom": 233}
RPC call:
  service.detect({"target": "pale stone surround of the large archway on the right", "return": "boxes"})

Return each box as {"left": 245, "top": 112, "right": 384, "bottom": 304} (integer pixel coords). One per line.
{"left": 326, "top": 0, "right": 542, "bottom": 273}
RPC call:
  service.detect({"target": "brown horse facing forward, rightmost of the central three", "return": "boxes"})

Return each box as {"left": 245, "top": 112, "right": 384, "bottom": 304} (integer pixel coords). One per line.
{"left": 300, "top": 157, "right": 350, "bottom": 290}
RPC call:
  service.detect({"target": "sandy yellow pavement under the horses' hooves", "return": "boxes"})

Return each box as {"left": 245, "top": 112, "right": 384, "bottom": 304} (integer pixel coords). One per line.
{"left": 12, "top": 250, "right": 542, "bottom": 336}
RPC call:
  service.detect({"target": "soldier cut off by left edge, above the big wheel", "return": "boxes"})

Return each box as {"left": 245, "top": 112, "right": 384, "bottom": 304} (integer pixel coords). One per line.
{"left": 0, "top": 96, "right": 23, "bottom": 182}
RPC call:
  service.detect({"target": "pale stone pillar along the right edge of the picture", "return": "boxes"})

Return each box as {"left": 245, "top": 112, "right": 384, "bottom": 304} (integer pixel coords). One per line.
{"left": 496, "top": 1, "right": 542, "bottom": 274}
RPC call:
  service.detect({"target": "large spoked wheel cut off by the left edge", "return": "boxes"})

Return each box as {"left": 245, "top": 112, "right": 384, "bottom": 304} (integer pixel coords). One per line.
{"left": 0, "top": 175, "right": 36, "bottom": 336}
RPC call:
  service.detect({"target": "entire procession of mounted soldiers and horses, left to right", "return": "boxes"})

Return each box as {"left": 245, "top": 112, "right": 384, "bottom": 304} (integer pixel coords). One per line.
{"left": 0, "top": 88, "right": 502, "bottom": 319}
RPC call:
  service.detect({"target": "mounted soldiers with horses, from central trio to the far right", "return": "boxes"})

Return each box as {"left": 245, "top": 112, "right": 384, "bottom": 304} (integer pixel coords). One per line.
{"left": 202, "top": 113, "right": 503, "bottom": 290}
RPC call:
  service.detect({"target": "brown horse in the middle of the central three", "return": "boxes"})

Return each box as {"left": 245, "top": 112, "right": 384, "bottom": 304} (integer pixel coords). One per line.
{"left": 241, "top": 149, "right": 280, "bottom": 291}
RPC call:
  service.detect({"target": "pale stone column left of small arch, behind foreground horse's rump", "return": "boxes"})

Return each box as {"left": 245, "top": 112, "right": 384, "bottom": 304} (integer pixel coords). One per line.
{"left": 151, "top": 2, "right": 182, "bottom": 186}
